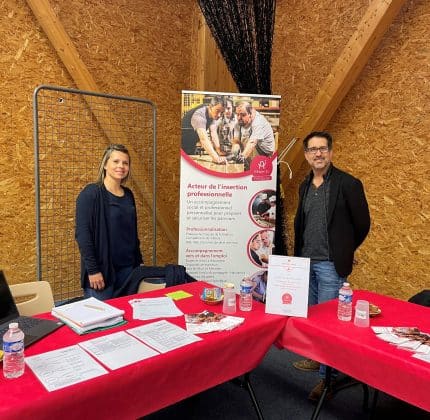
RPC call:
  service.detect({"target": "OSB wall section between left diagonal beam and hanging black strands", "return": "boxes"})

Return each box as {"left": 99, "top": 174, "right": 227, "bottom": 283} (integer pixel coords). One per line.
{"left": 47, "top": 0, "right": 192, "bottom": 264}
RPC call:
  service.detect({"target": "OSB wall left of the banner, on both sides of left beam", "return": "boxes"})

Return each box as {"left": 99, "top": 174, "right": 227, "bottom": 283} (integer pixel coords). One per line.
{"left": 0, "top": 0, "right": 194, "bottom": 283}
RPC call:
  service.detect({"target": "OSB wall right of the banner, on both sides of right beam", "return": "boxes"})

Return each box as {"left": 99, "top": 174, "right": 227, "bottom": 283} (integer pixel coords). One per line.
{"left": 273, "top": 0, "right": 430, "bottom": 299}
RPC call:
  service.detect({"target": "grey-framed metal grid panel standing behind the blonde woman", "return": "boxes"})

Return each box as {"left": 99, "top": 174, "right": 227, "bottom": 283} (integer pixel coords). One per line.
{"left": 33, "top": 85, "right": 157, "bottom": 301}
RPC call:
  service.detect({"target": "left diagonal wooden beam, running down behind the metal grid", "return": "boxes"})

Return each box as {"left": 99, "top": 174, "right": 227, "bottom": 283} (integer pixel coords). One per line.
{"left": 27, "top": 0, "right": 178, "bottom": 251}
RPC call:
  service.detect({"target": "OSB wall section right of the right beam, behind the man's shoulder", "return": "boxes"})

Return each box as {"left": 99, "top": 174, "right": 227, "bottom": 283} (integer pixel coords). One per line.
{"left": 329, "top": 1, "right": 430, "bottom": 298}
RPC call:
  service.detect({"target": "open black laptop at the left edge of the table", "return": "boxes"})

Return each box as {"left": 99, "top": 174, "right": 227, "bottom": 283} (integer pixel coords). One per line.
{"left": 0, "top": 270, "right": 64, "bottom": 349}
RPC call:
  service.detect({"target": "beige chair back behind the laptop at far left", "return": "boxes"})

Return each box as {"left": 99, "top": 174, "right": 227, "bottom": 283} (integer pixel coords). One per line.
{"left": 9, "top": 281, "right": 55, "bottom": 316}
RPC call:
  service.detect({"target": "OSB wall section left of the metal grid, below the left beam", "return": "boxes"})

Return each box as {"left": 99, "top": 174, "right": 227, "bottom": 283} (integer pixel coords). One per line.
{"left": 0, "top": 0, "right": 71, "bottom": 283}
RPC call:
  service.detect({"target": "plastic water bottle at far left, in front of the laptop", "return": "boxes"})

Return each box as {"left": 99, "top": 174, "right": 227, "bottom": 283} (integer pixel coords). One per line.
{"left": 3, "top": 322, "right": 25, "bottom": 379}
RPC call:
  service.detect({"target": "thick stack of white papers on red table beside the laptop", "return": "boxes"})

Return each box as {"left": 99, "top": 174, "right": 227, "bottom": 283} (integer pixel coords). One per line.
{"left": 51, "top": 297, "right": 124, "bottom": 334}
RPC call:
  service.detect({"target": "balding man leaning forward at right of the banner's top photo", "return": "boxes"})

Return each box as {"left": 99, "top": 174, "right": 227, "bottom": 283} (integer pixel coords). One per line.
{"left": 232, "top": 101, "right": 275, "bottom": 170}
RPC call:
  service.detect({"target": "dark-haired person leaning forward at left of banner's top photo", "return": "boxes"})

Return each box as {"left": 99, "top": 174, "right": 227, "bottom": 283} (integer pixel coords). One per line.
{"left": 182, "top": 96, "right": 226, "bottom": 164}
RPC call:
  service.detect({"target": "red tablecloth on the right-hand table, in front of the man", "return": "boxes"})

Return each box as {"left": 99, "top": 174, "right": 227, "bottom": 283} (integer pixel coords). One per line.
{"left": 279, "top": 291, "right": 430, "bottom": 411}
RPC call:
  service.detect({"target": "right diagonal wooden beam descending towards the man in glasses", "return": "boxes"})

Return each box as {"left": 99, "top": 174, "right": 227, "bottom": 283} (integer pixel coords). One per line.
{"left": 282, "top": 0, "right": 406, "bottom": 183}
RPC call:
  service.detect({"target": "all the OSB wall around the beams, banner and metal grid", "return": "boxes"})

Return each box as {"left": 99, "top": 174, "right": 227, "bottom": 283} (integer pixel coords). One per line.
{"left": 0, "top": 0, "right": 430, "bottom": 298}
